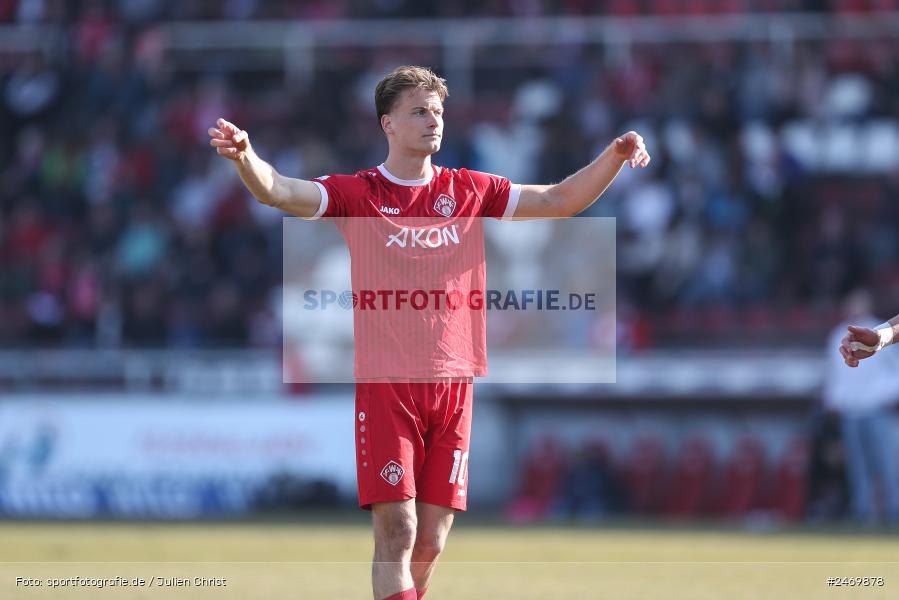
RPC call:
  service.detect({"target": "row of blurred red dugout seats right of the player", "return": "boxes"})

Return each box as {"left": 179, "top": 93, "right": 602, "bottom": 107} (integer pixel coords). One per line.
{"left": 505, "top": 432, "right": 812, "bottom": 523}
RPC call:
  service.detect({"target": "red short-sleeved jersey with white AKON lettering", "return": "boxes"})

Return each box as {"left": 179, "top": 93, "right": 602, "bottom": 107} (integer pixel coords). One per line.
{"left": 312, "top": 165, "right": 521, "bottom": 379}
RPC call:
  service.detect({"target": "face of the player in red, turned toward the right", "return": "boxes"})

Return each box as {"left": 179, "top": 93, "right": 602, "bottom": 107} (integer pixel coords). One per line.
{"left": 381, "top": 88, "right": 443, "bottom": 155}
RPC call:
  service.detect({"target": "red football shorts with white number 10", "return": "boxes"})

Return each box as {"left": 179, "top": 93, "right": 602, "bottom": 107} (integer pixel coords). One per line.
{"left": 355, "top": 378, "right": 473, "bottom": 510}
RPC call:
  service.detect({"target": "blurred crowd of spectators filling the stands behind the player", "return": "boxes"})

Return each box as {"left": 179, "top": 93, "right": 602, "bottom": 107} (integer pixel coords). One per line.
{"left": 0, "top": 0, "right": 899, "bottom": 349}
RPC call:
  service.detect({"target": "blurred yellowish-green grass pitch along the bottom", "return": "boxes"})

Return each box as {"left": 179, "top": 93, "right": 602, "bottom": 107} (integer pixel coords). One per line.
{"left": 0, "top": 516, "right": 899, "bottom": 600}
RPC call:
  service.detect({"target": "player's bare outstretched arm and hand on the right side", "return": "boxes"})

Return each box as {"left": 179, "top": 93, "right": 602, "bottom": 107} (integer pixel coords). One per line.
{"left": 512, "top": 131, "right": 650, "bottom": 219}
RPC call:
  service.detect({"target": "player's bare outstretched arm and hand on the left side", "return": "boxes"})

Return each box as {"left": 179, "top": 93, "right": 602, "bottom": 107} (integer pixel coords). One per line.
{"left": 209, "top": 119, "right": 322, "bottom": 219}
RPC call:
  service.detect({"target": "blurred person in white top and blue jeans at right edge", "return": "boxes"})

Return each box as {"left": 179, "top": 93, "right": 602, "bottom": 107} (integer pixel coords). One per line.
{"left": 824, "top": 290, "right": 899, "bottom": 523}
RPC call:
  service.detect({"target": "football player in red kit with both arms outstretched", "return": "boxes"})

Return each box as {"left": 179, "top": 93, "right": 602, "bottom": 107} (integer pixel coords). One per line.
{"left": 209, "top": 66, "right": 650, "bottom": 600}
